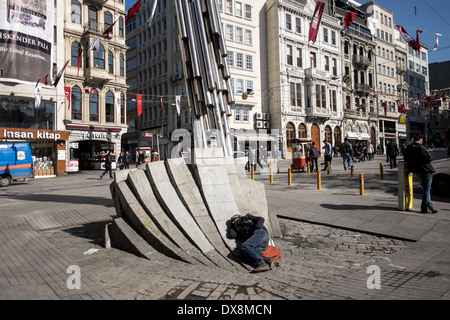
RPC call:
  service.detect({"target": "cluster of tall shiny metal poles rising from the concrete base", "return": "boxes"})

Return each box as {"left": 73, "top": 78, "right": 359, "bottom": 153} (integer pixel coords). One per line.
{"left": 175, "top": 0, "right": 235, "bottom": 155}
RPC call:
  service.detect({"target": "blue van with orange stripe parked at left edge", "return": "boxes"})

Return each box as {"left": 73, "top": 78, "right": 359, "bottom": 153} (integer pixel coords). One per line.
{"left": 0, "top": 142, "right": 34, "bottom": 187}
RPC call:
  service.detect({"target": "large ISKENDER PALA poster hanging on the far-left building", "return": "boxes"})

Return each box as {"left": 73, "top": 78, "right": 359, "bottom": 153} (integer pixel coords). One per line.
{"left": 0, "top": 0, "right": 54, "bottom": 84}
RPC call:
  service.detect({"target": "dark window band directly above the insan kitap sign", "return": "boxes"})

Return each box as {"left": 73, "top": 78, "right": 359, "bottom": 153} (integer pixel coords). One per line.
{"left": 0, "top": 97, "right": 55, "bottom": 130}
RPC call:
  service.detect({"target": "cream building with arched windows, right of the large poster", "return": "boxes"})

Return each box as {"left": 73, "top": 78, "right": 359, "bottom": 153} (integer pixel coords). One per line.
{"left": 61, "top": 0, "right": 127, "bottom": 169}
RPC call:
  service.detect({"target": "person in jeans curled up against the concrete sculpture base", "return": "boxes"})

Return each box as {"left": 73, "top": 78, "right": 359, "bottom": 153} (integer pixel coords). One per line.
{"left": 227, "top": 214, "right": 272, "bottom": 273}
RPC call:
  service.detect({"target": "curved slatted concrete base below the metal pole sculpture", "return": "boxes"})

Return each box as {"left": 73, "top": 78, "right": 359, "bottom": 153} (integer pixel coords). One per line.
{"left": 110, "top": 148, "right": 281, "bottom": 270}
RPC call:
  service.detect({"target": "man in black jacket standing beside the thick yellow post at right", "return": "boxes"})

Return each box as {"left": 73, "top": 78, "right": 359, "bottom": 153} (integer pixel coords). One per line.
{"left": 404, "top": 136, "right": 437, "bottom": 213}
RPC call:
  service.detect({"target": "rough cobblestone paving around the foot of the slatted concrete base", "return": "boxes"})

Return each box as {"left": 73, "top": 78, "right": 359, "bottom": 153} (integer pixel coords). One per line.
{"left": 42, "top": 219, "right": 408, "bottom": 300}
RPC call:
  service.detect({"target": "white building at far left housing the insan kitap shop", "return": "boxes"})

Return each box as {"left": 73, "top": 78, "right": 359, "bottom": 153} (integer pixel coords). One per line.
{"left": 0, "top": 1, "right": 68, "bottom": 177}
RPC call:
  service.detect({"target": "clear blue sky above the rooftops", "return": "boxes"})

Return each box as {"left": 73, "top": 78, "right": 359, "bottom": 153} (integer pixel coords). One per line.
{"left": 125, "top": 0, "right": 450, "bottom": 63}
